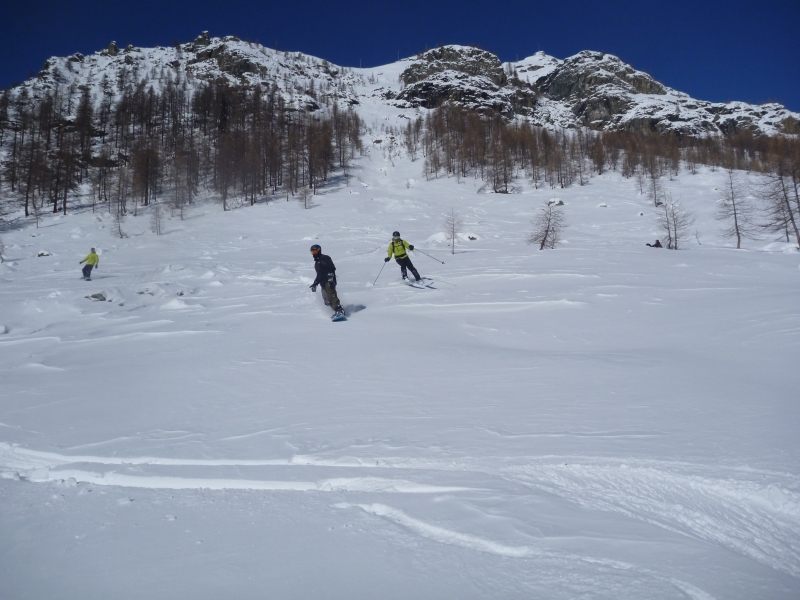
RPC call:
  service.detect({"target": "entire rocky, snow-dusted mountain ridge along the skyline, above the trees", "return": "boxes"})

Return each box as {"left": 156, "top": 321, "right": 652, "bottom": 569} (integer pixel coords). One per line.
{"left": 13, "top": 32, "right": 800, "bottom": 135}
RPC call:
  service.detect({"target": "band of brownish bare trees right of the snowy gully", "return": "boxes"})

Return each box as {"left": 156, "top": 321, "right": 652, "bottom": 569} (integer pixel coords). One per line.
{"left": 404, "top": 104, "right": 800, "bottom": 248}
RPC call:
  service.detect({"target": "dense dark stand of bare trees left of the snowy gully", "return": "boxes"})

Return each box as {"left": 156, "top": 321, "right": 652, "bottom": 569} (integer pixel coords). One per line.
{"left": 0, "top": 74, "right": 362, "bottom": 225}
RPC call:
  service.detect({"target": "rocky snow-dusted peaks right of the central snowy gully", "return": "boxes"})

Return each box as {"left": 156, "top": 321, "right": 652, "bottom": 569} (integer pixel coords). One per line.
{"left": 387, "top": 46, "right": 800, "bottom": 136}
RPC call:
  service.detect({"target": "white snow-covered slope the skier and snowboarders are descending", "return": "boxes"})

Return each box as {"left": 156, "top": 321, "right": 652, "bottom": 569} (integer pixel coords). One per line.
{"left": 0, "top": 108, "right": 800, "bottom": 600}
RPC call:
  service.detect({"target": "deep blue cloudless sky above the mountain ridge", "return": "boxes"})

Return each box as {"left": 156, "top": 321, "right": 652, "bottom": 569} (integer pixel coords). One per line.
{"left": 0, "top": 0, "right": 800, "bottom": 111}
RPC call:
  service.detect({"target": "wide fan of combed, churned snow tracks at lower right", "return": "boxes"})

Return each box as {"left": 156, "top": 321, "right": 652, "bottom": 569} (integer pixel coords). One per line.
{"left": 504, "top": 457, "right": 800, "bottom": 577}
